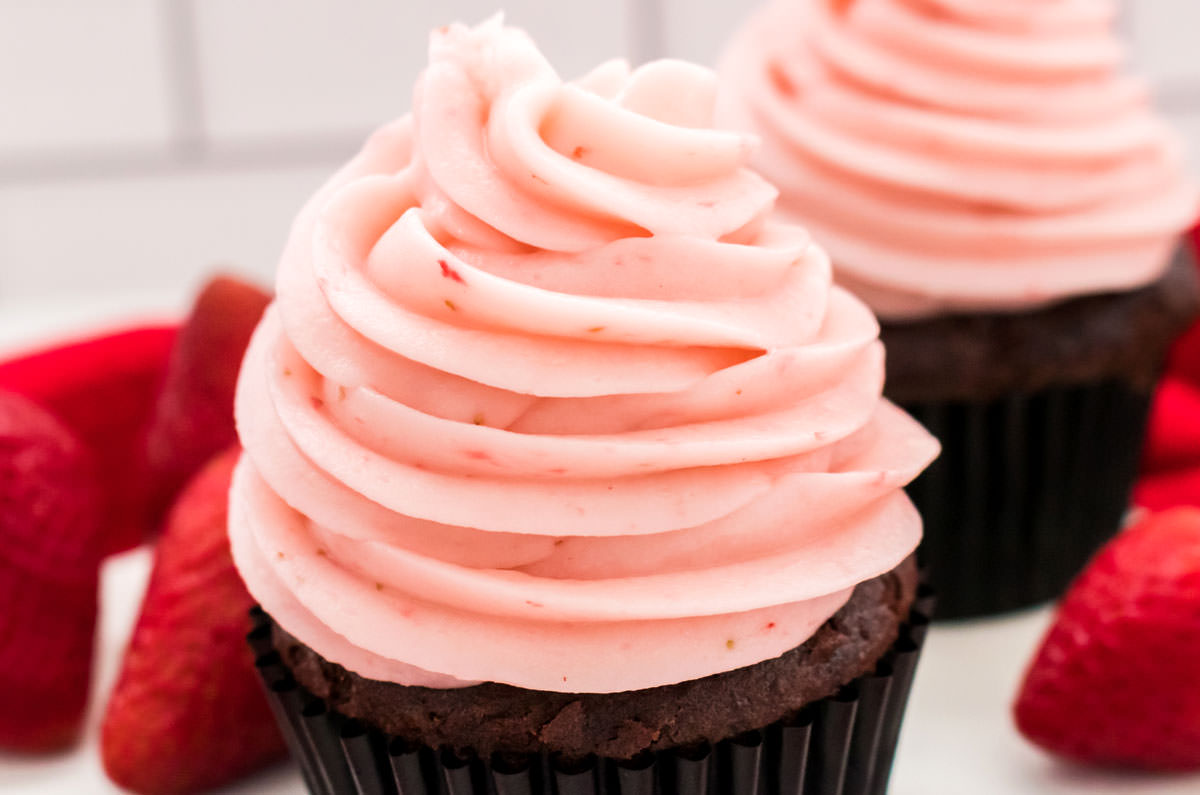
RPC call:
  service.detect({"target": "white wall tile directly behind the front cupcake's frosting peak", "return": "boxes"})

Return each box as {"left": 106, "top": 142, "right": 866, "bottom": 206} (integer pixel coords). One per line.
{"left": 194, "top": 0, "right": 635, "bottom": 141}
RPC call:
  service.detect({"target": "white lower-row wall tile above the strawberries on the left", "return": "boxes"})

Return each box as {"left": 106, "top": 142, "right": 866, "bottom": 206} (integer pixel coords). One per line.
{"left": 0, "top": 162, "right": 334, "bottom": 307}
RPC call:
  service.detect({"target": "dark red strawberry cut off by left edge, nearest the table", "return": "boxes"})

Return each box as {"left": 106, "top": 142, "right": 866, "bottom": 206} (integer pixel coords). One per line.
{"left": 0, "top": 391, "right": 102, "bottom": 752}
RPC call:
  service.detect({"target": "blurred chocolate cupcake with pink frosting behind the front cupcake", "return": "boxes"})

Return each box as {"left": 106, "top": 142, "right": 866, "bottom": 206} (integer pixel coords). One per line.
{"left": 718, "top": 0, "right": 1198, "bottom": 617}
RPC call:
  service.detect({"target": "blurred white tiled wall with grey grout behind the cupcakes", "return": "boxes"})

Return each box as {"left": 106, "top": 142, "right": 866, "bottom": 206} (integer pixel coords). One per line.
{"left": 0, "top": 0, "right": 1200, "bottom": 319}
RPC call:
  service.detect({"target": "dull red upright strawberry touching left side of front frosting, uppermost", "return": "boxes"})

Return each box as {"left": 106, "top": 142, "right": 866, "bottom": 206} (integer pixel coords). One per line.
{"left": 145, "top": 276, "right": 271, "bottom": 533}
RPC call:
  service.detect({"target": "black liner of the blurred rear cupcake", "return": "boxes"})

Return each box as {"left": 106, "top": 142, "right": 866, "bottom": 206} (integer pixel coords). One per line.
{"left": 904, "top": 381, "right": 1152, "bottom": 620}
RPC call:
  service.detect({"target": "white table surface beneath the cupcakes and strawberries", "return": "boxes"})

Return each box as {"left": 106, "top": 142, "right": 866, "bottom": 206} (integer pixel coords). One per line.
{"left": 0, "top": 300, "right": 1200, "bottom": 795}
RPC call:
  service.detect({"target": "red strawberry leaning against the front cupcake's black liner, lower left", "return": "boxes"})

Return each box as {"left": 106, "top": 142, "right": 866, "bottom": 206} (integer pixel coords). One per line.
{"left": 101, "top": 449, "right": 284, "bottom": 795}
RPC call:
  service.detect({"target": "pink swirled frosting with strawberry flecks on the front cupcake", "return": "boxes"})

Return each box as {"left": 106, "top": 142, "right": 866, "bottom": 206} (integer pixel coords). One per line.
{"left": 230, "top": 15, "right": 937, "bottom": 693}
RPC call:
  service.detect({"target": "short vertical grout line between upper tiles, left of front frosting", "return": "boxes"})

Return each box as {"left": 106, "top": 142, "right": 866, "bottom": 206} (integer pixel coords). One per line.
{"left": 162, "top": 0, "right": 208, "bottom": 161}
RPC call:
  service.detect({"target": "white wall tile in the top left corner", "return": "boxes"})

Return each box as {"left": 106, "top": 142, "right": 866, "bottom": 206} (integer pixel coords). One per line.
{"left": 0, "top": 0, "right": 170, "bottom": 159}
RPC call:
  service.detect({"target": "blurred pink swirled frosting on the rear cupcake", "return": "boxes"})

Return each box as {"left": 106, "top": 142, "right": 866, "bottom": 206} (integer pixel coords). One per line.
{"left": 718, "top": 0, "right": 1198, "bottom": 319}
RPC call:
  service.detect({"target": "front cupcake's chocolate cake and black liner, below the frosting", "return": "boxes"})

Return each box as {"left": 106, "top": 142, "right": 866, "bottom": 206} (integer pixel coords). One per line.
{"left": 250, "top": 560, "right": 934, "bottom": 795}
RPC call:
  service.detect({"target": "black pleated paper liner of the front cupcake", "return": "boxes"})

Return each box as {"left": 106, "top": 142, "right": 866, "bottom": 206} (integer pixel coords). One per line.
{"left": 250, "top": 586, "right": 932, "bottom": 795}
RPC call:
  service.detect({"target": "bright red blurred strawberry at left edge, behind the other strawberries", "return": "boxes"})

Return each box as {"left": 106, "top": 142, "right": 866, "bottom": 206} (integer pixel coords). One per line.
{"left": 0, "top": 325, "right": 175, "bottom": 552}
